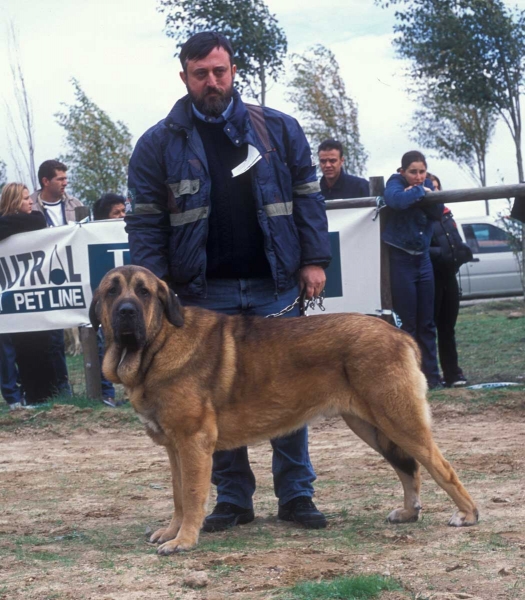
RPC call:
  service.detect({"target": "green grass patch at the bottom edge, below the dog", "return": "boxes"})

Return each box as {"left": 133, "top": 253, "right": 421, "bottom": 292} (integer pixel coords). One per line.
{"left": 279, "top": 575, "right": 402, "bottom": 600}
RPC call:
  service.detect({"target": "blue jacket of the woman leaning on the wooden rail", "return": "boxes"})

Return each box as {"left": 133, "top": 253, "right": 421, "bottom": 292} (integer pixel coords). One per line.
{"left": 382, "top": 173, "right": 444, "bottom": 253}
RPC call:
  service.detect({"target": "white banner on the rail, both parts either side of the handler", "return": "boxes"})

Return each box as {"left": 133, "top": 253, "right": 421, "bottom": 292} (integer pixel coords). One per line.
{"left": 0, "top": 208, "right": 381, "bottom": 333}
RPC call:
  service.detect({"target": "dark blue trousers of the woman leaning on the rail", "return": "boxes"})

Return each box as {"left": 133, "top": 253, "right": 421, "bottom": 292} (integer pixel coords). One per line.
{"left": 389, "top": 246, "right": 441, "bottom": 387}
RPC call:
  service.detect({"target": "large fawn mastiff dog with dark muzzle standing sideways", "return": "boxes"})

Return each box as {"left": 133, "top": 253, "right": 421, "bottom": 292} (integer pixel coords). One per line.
{"left": 90, "top": 266, "right": 478, "bottom": 554}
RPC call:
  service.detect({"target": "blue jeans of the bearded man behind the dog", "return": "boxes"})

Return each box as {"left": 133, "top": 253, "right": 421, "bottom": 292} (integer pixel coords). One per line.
{"left": 180, "top": 279, "right": 316, "bottom": 509}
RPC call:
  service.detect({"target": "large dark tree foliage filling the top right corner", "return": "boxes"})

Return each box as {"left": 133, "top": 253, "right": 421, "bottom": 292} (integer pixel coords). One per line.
{"left": 376, "top": 0, "right": 525, "bottom": 180}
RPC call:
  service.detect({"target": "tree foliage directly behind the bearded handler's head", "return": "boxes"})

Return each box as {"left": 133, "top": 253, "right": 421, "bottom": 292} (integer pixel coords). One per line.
{"left": 159, "top": 0, "right": 287, "bottom": 105}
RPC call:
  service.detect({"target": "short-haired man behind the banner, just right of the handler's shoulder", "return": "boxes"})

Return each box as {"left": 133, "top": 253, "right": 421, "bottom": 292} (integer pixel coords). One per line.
{"left": 317, "top": 139, "right": 370, "bottom": 200}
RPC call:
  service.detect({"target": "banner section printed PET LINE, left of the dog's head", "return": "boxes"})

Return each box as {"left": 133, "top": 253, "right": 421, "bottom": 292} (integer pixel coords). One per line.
{"left": 0, "top": 220, "right": 129, "bottom": 333}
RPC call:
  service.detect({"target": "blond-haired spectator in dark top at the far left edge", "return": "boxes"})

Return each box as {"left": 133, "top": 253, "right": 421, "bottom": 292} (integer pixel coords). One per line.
{"left": 0, "top": 183, "right": 58, "bottom": 409}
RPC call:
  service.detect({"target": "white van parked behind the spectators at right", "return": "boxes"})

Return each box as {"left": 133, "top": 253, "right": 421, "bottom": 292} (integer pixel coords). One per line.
{"left": 454, "top": 217, "right": 523, "bottom": 298}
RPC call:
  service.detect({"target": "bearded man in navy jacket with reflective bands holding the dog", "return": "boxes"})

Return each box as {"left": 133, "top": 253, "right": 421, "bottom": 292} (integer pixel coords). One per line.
{"left": 126, "top": 32, "right": 330, "bottom": 531}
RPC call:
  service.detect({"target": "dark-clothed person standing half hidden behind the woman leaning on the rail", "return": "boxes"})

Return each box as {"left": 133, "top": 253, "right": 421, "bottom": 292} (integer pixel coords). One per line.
{"left": 429, "top": 174, "right": 473, "bottom": 387}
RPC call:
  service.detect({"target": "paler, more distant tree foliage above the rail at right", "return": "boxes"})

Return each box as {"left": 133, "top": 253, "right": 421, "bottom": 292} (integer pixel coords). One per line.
{"left": 411, "top": 91, "right": 496, "bottom": 186}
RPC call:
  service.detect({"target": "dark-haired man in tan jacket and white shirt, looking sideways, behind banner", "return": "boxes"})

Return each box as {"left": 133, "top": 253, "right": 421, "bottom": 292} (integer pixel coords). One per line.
{"left": 31, "top": 160, "right": 83, "bottom": 395}
